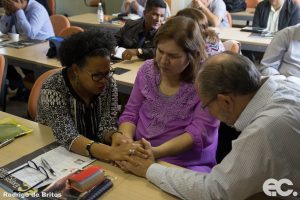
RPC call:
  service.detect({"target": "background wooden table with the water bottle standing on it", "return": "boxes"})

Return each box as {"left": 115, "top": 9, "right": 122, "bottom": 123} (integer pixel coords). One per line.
{"left": 69, "top": 13, "right": 124, "bottom": 31}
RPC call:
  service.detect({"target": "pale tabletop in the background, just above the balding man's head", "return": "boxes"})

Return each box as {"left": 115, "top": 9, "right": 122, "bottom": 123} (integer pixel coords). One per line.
{"left": 213, "top": 28, "right": 272, "bottom": 52}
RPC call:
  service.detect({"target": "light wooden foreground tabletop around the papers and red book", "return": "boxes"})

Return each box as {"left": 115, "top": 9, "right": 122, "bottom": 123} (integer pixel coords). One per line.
{"left": 0, "top": 111, "right": 176, "bottom": 200}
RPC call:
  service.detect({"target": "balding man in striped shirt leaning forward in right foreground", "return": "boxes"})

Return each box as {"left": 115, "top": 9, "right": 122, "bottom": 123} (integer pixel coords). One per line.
{"left": 122, "top": 52, "right": 300, "bottom": 200}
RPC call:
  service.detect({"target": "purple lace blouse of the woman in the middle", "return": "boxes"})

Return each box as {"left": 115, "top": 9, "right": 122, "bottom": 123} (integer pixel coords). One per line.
{"left": 119, "top": 60, "right": 219, "bottom": 172}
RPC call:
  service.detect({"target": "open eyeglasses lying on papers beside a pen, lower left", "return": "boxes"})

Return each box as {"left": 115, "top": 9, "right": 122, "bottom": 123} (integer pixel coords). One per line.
{"left": 0, "top": 160, "right": 50, "bottom": 193}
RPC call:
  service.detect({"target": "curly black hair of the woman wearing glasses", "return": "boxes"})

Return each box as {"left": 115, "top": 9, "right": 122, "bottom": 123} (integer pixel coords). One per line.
{"left": 59, "top": 29, "right": 116, "bottom": 67}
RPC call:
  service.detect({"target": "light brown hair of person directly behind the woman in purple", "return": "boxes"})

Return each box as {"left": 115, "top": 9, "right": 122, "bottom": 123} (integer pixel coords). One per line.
{"left": 176, "top": 8, "right": 219, "bottom": 43}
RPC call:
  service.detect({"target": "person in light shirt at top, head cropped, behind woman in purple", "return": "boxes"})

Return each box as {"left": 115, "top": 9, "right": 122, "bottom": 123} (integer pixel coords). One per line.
{"left": 188, "top": 0, "right": 229, "bottom": 27}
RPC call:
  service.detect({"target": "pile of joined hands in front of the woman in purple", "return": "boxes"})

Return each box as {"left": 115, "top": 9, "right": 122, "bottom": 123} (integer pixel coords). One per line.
{"left": 112, "top": 134, "right": 155, "bottom": 177}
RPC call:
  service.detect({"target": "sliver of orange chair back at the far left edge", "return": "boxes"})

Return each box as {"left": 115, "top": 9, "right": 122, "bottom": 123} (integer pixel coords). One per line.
{"left": 0, "top": 55, "right": 7, "bottom": 111}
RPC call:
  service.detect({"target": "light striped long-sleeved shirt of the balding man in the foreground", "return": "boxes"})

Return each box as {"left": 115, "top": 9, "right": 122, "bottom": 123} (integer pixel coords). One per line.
{"left": 146, "top": 76, "right": 300, "bottom": 200}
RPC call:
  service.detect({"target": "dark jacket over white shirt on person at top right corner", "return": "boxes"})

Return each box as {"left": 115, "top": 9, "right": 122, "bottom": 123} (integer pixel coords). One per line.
{"left": 253, "top": 0, "right": 300, "bottom": 30}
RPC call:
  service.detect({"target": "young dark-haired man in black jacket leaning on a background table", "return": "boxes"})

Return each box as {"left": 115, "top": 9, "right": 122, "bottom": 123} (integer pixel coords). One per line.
{"left": 115, "top": 0, "right": 166, "bottom": 60}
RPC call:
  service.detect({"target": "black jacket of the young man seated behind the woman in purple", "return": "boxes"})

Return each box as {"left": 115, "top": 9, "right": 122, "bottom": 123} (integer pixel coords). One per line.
{"left": 115, "top": 18, "right": 157, "bottom": 59}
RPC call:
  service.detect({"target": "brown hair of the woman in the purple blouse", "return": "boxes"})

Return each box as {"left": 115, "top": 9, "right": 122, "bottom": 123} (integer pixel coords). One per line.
{"left": 154, "top": 16, "right": 207, "bottom": 82}
